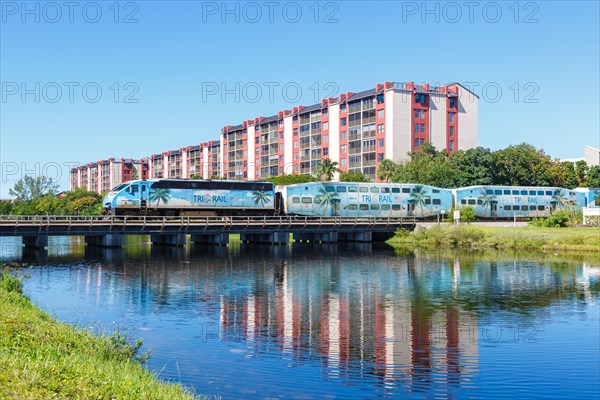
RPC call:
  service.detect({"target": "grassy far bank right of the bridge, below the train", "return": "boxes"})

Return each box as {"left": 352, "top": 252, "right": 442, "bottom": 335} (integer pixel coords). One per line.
{"left": 388, "top": 224, "right": 600, "bottom": 252}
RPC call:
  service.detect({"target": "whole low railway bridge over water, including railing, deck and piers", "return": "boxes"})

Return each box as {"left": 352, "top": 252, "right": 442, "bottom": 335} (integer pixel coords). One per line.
{"left": 0, "top": 215, "right": 416, "bottom": 248}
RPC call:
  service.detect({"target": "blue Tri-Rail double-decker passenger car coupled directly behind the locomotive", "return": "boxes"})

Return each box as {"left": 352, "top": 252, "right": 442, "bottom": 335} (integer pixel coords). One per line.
{"left": 277, "top": 182, "right": 452, "bottom": 218}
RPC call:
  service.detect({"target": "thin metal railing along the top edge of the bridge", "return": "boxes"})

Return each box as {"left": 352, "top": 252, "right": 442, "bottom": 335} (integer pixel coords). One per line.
{"left": 0, "top": 215, "right": 416, "bottom": 226}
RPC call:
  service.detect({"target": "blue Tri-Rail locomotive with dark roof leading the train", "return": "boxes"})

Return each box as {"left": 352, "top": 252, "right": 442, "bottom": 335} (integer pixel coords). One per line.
{"left": 102, "top": 179, "right": 279, "bottom": 216}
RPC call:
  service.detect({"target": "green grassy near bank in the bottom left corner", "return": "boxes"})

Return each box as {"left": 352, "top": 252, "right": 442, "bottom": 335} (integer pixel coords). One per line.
{"left": 0, "top": 266, "right": 194, "bottom": 399}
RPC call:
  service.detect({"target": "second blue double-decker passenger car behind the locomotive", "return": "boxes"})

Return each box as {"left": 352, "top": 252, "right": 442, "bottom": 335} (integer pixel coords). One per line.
{"left": 454, "top": 186, "right": 586, "bottom": 219}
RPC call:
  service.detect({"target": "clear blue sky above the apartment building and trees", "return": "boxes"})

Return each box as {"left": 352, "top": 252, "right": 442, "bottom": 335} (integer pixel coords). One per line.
{"left": 0, "top": 0, "right": 600, "bottom": 198}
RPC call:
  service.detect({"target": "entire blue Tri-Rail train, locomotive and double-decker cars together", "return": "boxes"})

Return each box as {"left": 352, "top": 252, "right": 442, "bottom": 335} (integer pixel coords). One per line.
{"left": 102, "top": 179, "right": 600, "bottom": 219}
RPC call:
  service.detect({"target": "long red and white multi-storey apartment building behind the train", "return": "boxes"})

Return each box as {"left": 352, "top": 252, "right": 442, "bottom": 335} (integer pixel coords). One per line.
{"left": 71, "top": 82, "right": 478, "bottom": 190}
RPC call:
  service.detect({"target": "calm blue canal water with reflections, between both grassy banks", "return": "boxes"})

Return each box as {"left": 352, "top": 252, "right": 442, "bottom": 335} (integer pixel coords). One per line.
{"left": 0, "top": 237, "right": 600, "bottom": 399}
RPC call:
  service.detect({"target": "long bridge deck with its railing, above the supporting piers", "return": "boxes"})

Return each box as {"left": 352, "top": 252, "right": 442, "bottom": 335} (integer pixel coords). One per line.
{"left": 0, "top": 216, "right": 416, "bottom": 236}
